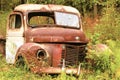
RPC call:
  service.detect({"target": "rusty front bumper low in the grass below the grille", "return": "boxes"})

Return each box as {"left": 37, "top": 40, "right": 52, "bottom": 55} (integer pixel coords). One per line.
{"left": 31, "top": 66, "right": 81, "bottom": 76}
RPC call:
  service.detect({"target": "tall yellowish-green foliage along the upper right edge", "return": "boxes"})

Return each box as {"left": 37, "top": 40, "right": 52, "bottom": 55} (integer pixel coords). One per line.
{"left": 96, "top": 1, "right": 120, "bottom": 42}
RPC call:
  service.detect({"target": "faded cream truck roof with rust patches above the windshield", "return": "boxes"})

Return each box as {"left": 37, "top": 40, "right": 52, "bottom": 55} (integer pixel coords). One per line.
{"left": 14, "top": 4, "right": 80, "bottom": 14}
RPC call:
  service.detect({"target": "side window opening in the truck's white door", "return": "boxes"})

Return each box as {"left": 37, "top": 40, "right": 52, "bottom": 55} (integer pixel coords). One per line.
{"left": 9, "top": 14, "right": 22, "bottom": 29}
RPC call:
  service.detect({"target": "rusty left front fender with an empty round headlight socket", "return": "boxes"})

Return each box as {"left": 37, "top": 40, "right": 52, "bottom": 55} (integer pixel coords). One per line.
{"left": 15, "top": 43, "right": 50, "bottom": 68}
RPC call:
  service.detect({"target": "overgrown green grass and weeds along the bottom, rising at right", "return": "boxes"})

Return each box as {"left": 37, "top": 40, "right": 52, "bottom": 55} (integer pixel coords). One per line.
{"left": 0, "top": 40, "right": 120, "bottom": 80}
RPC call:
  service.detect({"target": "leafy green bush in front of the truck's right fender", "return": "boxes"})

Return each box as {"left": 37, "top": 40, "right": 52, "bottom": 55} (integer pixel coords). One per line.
{"left": 87, "top": 48, "right": 113, "bottom": 72}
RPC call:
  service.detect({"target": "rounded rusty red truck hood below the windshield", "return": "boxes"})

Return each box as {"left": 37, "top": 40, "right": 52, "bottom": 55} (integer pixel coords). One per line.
{"left": 26, "top": 28, "right": 88, "bottom": 43}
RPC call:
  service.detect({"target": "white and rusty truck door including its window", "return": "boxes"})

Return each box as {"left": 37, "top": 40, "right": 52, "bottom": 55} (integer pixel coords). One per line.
{"left": 6, "top": 12, "right": 24, "bottom": 64}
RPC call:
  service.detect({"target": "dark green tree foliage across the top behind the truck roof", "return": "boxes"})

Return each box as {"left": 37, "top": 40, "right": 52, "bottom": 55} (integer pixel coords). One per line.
{"left": 0, "top": 0, "right": 120, "bottom": 17}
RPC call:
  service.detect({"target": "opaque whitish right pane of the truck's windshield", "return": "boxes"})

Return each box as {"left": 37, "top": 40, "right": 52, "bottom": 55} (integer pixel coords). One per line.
{"left": 55, "top": 12, "right": 79, "bottom": 28}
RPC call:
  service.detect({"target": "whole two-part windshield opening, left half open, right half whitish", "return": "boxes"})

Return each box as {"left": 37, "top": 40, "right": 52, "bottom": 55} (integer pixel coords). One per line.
{"left": 28, "top": 12, "right": 79, "bottom": 28}
